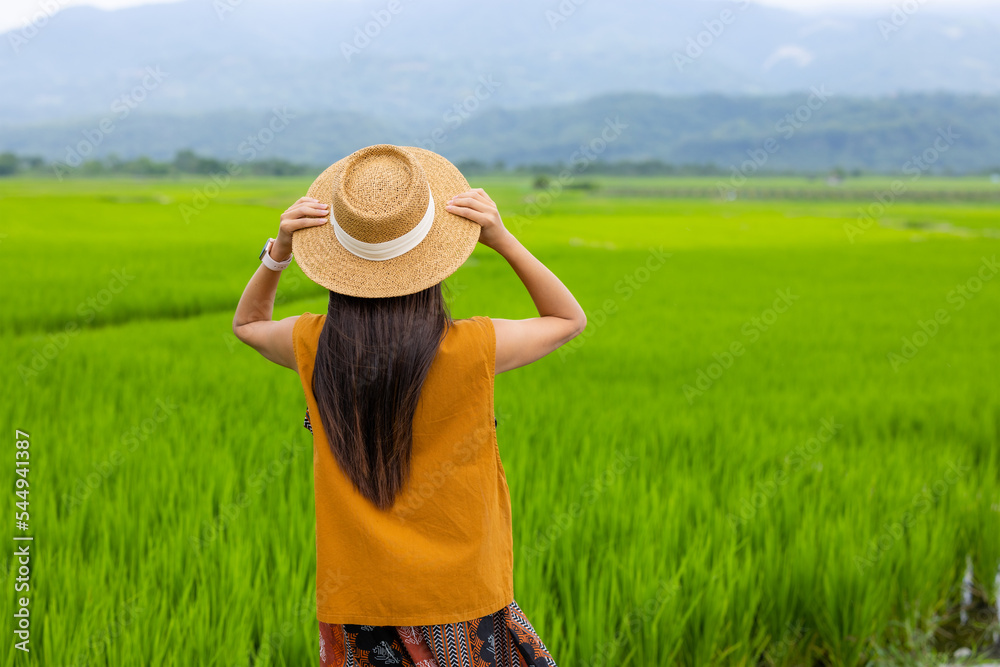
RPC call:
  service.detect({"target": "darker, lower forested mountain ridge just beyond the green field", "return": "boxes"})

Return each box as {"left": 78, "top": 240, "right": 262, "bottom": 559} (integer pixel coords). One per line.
{"left": 7, "top": 92, "right": 1000, "bottom": 173}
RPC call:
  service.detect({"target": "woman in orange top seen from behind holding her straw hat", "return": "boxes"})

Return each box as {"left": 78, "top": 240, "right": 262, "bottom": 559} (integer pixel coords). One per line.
{"left": 233, "top": 144, "right": 586, "bottom": 667}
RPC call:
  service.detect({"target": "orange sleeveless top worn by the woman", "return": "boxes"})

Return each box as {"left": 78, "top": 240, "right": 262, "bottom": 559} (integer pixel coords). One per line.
{"left": 292, "top": 313, "right": 514, "bottom": 626}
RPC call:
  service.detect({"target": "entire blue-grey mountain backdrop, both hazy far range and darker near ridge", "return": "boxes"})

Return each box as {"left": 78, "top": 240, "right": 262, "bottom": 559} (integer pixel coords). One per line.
{"left": 0, "top": 0, "right": 1000, "bottom": 171}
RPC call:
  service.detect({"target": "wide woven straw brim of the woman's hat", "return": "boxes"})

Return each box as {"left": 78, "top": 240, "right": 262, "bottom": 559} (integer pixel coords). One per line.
{"left": 292, "top": 146, "right": 481, "bottom": 298}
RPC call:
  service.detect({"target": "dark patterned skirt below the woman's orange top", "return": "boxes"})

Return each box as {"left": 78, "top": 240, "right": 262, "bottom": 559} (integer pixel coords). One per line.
{"left": 319, "top": 602, "right": 556, "bottom": 667}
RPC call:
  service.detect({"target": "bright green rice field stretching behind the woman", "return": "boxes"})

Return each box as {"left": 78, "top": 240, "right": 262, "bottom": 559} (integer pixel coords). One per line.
{"left": 0, "top": 176, "right": 1000, "bottom": 667}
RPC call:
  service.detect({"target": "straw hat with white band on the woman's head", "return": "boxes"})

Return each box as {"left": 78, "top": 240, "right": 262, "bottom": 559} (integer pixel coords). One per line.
{"left": 292, "top": 144, "right": 481, "bottom": 298}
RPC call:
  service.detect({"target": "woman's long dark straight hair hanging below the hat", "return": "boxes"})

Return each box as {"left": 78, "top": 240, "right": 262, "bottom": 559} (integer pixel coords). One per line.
{"left": 313, "top": 283, "right": 451, "bottom": 509}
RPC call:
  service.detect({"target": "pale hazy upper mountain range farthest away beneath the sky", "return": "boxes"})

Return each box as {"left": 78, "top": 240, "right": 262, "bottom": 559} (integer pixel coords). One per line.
{"left": 0, "top": 0, "right": 1000, "bottom": 127}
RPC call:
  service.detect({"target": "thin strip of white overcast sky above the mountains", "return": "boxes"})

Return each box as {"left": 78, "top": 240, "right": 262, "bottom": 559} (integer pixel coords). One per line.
{"left": 0, "top": 0, "right": 1000, "bottom": 31}
